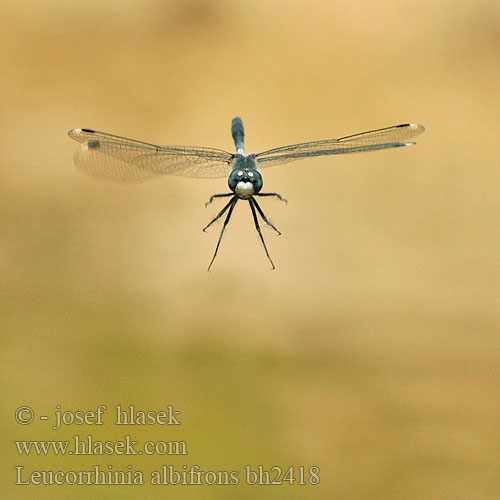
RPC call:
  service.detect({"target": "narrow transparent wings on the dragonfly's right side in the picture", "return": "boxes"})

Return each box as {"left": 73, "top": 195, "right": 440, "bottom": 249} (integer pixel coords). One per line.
{"left": 256, "top": 123, "right": 425, "bottom": 168}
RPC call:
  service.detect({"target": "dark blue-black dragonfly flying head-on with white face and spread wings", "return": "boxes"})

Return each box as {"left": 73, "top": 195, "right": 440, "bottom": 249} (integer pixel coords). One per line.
{"left": 68, "top": 117, "right": 425, "bottom": 271}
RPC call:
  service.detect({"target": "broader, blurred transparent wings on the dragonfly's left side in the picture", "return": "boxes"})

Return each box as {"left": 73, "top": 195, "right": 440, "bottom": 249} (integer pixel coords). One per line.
{"left": 68, "top": 129, "right": 233, "bottom": 182}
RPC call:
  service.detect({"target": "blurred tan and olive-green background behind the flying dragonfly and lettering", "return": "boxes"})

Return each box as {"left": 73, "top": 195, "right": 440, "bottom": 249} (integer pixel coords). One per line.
{"left": 0, "top": 0, "right": 500, "bottom": 500}
